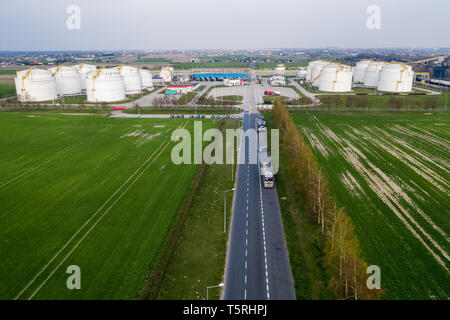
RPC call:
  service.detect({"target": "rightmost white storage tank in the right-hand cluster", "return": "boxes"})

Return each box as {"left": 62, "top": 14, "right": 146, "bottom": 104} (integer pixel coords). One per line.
{"left": 377, "top": 63, "right": 414, "bottom": 92}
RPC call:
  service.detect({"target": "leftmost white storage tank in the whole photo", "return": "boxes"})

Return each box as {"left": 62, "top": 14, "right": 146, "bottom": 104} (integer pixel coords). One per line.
{"left": 14, "top": 68, "right": 57, "bottom": 102}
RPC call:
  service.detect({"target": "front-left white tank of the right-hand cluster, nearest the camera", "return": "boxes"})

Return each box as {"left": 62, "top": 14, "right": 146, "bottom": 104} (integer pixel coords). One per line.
{"left": 319, "top": 63, "right": 353, "bottom": 92}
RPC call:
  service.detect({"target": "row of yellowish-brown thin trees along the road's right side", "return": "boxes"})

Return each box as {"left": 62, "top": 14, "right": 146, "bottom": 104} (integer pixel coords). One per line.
{"left": 273, "top": 99, "right": 381, "bottom": 300}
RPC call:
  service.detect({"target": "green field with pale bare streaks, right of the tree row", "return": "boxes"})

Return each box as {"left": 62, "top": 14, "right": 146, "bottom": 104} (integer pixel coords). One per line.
{"left": 292, "top": 114, "right": 450, "bottom": 299}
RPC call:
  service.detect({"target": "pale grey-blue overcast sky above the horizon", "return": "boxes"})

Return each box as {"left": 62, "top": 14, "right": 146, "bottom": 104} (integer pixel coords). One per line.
{"left": 0, "top": 0, "right": 450, "bottom": 51}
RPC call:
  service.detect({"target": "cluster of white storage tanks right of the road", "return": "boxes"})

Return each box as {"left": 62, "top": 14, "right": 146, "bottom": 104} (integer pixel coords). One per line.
{"left": 306, "top": 60, "right": 414, "bottom": 92}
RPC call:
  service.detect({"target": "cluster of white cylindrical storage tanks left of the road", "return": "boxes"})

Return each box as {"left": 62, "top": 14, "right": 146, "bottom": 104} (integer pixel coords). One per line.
{"left": 15, "top": 64, "right": 153, "bottom": 102}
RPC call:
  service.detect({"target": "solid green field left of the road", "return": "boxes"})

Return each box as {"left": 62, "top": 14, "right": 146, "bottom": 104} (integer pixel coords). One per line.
{"left": 0, "top": 113, "right": 217, "bottom": 299}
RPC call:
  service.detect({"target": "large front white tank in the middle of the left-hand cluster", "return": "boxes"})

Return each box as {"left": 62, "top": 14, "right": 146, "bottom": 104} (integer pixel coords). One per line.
{"left": 86, "top": 69, "right": 126, "bottom": 102}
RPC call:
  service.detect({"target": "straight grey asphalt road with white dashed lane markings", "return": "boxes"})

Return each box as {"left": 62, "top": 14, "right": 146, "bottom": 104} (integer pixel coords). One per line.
{"left": 223, "top": 108, "right": 295, "bottom": 300}
